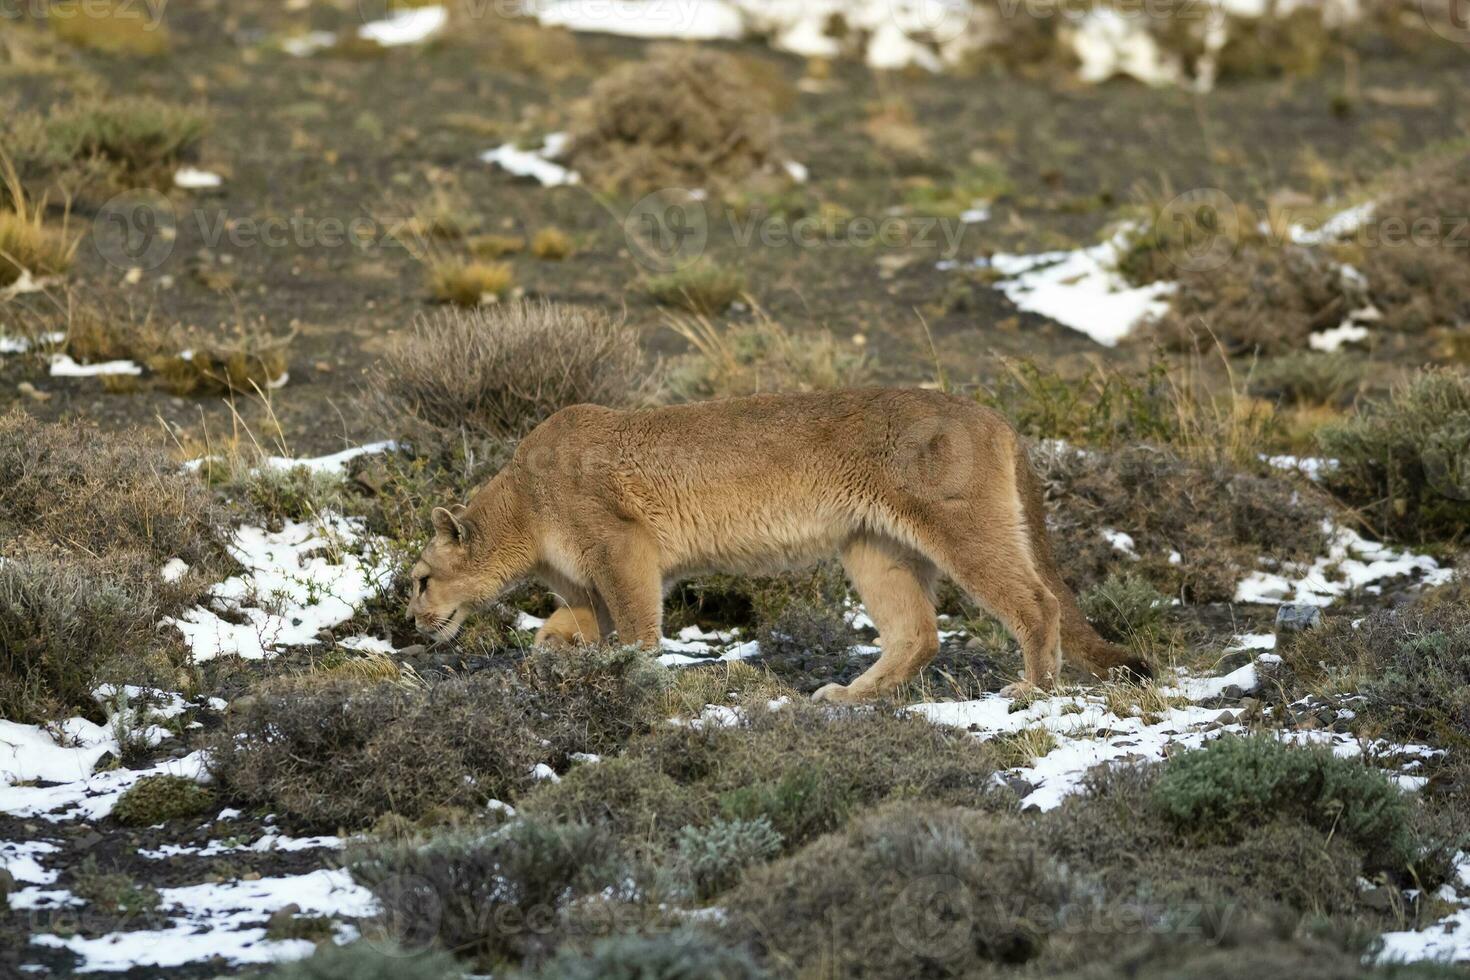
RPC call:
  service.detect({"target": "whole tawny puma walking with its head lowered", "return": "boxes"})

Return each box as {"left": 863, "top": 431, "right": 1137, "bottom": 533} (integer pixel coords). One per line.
{"left": 410, "top": 388, "right": 1147, "bottom": 701}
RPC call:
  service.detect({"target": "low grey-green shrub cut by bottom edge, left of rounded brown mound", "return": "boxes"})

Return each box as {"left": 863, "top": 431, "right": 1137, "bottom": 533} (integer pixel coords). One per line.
{"left": 526, "top": 930, "right": 769, "bottom": 980}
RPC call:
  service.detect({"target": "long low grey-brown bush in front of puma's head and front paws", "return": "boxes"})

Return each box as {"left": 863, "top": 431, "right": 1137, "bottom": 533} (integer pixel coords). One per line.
{"left": 210, "top": 649, "right": 664, "bottom": 829}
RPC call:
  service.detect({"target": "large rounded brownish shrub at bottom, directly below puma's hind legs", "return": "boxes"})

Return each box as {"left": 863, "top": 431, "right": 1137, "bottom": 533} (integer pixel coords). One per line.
{"left": 723, "top": 802, "right": 1097, "bottom": 979}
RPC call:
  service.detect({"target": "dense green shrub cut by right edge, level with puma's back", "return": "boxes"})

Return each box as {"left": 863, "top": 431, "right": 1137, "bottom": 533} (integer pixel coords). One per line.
{"left": 1317, "top": 370, "right": 1470, "bottom": 541}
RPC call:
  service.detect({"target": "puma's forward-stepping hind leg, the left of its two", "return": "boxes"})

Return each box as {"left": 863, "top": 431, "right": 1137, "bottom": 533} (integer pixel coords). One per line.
{"left": 811, "top": 536, "right": 939, "bottom": 704}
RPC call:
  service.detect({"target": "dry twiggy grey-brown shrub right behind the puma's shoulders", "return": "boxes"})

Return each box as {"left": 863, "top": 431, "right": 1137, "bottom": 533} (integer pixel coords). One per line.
{"left": 366, "top": 301, "right": 650, "bottom": 445}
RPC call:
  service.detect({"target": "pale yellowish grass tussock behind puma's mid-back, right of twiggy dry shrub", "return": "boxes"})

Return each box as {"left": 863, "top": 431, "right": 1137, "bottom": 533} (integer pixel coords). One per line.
{"left": 669, "top": 311, "right": 872, "bottom": 400}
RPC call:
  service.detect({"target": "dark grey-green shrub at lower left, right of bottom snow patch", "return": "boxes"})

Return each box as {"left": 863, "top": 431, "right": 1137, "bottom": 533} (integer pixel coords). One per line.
{"left": 347, "top": 820, "right": 631, "bottom": 967}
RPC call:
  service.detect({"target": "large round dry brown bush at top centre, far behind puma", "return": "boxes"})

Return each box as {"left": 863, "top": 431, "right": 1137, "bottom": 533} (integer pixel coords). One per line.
{"left": 566, "top": 44, "right": 779, "bottom": 194}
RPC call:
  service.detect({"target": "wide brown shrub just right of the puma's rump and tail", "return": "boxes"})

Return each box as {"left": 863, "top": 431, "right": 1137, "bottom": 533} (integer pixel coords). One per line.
{"left": 1030, "top": 444, "right": 1330, "bottom": 602}
